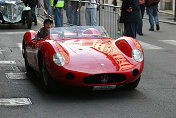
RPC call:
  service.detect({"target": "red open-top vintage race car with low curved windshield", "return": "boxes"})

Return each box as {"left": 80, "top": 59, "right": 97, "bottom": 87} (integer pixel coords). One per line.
{"left": 22, "top": 26, "right": 144, "bottom": 90}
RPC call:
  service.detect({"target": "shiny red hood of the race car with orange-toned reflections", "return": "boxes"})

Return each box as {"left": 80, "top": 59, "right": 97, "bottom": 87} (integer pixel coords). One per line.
{"left": 53, "top": 38, "right": 134, "bottom": 73}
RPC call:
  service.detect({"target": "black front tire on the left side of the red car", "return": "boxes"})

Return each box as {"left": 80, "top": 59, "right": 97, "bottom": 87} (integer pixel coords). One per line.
{"left": 41, "top": 57, "right": 54, "bottom": 93}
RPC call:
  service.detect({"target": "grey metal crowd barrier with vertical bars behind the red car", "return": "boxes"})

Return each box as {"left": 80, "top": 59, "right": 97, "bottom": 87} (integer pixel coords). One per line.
{"left": 37, "top": 1, "right": 124, "bottom": 38}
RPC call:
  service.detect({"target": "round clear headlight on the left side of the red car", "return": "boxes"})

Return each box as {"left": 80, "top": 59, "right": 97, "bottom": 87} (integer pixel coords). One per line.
{"left": 53, "top": 52, "right": 65, "bottom": 66}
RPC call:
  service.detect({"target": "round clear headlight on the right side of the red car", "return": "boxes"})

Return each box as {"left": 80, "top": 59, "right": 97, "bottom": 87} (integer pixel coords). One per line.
{"left": 132, "top": 49, "right": 144, "bottom": 62}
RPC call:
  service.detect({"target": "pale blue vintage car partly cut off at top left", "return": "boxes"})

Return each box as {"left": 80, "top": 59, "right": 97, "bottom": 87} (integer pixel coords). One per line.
{"left": 0, "top": 0, "right": 33, "bottom": 29}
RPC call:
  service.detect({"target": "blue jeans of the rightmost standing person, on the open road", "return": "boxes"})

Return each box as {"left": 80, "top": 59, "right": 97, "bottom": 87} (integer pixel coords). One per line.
{"left": 147, "top": 5, "right": 159, "bottom": 29}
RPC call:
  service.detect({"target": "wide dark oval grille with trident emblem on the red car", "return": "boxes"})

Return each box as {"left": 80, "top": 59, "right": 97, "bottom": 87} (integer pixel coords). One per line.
{"left": 83, "top": 74, "right": 126, "bottom": 84}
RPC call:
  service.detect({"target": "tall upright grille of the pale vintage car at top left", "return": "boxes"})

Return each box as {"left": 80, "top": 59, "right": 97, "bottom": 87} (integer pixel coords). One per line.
{"left": 7, "top": 4, "right": 18, "bottom": 22}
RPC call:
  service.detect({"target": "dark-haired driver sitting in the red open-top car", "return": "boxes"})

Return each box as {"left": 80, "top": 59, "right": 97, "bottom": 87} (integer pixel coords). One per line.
{"left": 37, "top": 19, "right": 53, "bottom": 40}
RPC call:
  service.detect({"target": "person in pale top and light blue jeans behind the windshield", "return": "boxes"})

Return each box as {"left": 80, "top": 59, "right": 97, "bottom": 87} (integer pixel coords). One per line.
{"left": 85, "top": 0, "right": 99, "bottom": 26}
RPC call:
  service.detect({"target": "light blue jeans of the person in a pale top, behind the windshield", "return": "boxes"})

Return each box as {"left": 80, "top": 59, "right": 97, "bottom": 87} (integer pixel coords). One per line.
{"left": 85, "top": 8, "right": 97, "bottom": 26}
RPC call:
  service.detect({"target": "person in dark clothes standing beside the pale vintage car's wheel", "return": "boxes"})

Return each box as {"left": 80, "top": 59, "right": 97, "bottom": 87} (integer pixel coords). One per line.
{"left": 24, "top": 0, "right": 38, "bottom": 25}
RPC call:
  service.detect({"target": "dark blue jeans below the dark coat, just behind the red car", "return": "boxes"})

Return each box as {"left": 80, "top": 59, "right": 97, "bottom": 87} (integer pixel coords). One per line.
{"left": 124, "top": 23, "right": 138, "bottom": 38}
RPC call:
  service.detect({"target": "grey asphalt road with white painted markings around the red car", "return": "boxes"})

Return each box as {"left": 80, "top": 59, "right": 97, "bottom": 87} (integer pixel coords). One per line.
{"left": 0, "top": 15, "right": 176, "bottom": 118}
